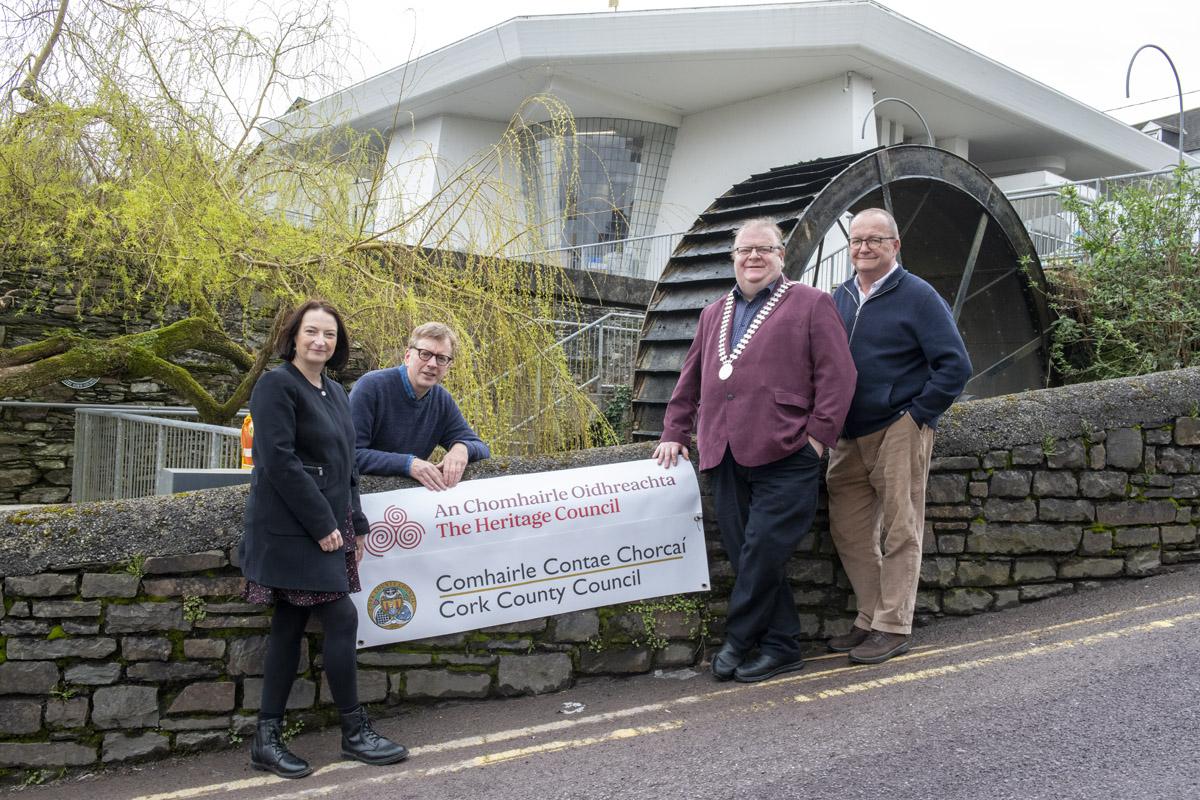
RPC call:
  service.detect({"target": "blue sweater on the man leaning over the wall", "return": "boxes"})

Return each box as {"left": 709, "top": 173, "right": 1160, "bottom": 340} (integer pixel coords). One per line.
{"left": 350, "top": 366, "right": 492, "bottom": 476}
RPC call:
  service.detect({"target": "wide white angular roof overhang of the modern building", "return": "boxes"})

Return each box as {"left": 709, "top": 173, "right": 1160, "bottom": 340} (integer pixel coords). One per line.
{"left": 274, "top": 0, "right": 1190, "bottom": 178}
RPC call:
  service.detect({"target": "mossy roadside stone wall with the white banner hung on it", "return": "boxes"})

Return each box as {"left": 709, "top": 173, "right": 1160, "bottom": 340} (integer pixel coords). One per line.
{"left": 0, "top": 369, "right": 1200, "bottom": 775}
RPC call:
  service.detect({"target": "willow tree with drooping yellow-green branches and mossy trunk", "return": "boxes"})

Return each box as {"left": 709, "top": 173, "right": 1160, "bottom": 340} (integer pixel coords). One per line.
{"left": 0, "top": 0, "right": 593, "bottom": 452}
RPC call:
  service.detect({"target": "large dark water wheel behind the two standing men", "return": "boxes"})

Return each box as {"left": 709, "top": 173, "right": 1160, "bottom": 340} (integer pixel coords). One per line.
{"left": 634, "top": 145, "right": 1050, "bottom": 438}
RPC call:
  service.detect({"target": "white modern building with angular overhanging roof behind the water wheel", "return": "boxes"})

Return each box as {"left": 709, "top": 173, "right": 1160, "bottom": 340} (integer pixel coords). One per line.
{"left": 274, "top": 0, "right": 1190, "bottom": 271}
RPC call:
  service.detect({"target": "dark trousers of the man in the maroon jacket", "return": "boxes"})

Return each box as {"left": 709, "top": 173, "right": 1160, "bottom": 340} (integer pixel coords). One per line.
{"left": 710, "top": 445, "right": 821, "bottom": 660}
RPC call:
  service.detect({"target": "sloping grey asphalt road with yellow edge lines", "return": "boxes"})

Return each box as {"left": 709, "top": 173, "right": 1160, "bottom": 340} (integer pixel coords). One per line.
{"left": 19, "top": 567, "right": 1200, "bottom": 800}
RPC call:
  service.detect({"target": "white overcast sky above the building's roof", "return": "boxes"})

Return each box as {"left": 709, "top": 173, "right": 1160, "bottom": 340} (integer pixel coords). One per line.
{"left": 333, "top": 0, "right": 1200, "bottom": 122}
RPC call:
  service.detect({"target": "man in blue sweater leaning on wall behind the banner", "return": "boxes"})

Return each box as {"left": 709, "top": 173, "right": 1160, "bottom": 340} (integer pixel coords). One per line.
{"left": 350, "top": 323, "right": 491, "bottom": 492}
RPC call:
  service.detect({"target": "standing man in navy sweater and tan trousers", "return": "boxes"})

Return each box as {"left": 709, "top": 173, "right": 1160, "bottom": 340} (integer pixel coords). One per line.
{"left": 826, "top": 209, "right": 971, "bottom": 663}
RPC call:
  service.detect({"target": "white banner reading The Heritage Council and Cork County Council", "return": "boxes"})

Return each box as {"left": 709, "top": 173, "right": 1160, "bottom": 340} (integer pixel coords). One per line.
{"left": 350, "top": 458, "right": 709, "bottom": 648}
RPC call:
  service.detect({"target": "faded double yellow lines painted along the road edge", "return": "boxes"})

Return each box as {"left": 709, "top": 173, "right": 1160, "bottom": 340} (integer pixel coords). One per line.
{"left": 124, "top": 594, "right": 1200, "bottom": 800}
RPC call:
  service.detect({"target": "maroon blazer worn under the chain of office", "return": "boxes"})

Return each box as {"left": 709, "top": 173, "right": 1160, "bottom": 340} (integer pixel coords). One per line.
{"left": 662, "top": 283, "right": 858, "bottom": 469}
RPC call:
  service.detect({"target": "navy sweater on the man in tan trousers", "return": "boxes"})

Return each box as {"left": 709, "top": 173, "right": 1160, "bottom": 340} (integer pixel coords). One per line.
{"left": 833, "top": 266, "right": 971, "bottom": 439}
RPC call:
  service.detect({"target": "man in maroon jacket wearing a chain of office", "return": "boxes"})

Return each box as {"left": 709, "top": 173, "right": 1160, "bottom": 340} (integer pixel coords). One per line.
{"left": 654, "top": 219, "right": 857, "bottom": 682}
